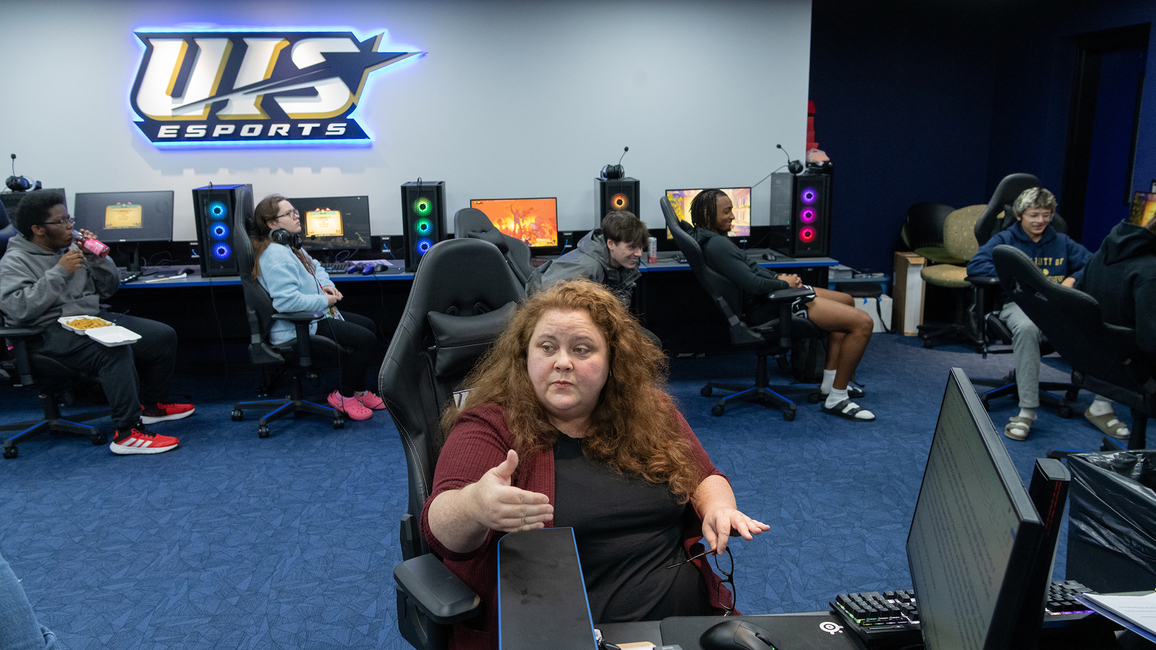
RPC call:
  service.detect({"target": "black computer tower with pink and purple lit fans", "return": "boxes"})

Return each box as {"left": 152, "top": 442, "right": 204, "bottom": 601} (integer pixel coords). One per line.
{"left": 770, "top": 173, "right": 831, "bottom": 258}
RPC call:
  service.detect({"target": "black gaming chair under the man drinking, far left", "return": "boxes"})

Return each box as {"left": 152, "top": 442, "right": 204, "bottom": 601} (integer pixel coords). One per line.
{"left": 0, "top": 325, "right": 109, "bottom": 458}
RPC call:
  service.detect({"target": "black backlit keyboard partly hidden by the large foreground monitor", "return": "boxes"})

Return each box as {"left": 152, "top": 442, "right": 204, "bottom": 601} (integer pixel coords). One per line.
{"left": 831, "top": 581, "right": 1092, "bottom": 650}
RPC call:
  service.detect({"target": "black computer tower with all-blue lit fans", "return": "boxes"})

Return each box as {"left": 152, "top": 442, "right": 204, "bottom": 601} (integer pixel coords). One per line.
{"left": 193, "top": 185, "right": 253, "bottom": 276}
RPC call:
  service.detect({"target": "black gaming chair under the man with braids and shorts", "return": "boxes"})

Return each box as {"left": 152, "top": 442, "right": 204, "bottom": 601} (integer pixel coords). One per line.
{"left": 659, "top": 197, "right": 823, "bottom": 422}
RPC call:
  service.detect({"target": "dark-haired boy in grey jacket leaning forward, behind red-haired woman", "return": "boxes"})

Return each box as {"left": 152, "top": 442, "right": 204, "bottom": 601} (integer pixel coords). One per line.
{"left": 526, "top": 210, "right": 650, "bottom": 309}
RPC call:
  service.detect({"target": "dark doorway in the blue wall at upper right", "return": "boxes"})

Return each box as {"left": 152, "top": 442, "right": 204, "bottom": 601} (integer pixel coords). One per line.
{"left": 1060, "top": 23, "right": 1150, "bottom": 251}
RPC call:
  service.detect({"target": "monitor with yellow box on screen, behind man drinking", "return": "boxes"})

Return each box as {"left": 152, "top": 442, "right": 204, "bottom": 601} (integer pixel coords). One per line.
{"left": 72, "top": 190, "right": 172, "bottom": 244}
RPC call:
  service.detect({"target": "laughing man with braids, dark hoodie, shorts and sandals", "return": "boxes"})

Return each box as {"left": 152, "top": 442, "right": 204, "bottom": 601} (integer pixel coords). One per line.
{"left": 690, "top": 190, "right": 875, "bottom": 422}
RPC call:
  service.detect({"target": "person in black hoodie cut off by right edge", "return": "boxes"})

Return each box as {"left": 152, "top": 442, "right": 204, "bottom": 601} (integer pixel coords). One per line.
{"left": 1076, "top": 219, "right": 1156, "bottom": 370}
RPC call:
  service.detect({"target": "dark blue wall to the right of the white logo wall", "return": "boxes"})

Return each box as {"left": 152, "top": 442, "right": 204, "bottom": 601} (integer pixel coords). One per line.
{"left": 810, "top": 0, "right": 1156, "bottom": 271}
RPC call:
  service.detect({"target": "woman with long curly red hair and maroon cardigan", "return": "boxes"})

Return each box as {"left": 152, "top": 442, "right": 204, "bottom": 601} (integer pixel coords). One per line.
{"left": 422, "top": 280, "right": 769, "bottom": 649}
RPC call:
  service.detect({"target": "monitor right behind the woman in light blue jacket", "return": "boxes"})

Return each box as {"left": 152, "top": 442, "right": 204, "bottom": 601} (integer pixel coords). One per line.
{"left": 288, "top": 197, "right": 372, "bottom": 251}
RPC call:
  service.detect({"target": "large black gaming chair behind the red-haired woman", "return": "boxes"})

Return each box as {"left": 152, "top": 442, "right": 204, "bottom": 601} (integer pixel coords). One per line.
{"left": 378, "top": 238, "right": 523, "bottom": 650}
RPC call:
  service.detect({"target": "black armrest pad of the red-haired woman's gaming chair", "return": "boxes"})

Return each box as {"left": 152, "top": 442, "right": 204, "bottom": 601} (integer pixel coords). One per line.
{"left": 393, "top": 553, "right": 482, "bottom": 625}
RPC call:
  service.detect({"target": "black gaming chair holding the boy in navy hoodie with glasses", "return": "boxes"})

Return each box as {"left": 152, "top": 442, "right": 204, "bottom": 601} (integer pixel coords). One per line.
{"left": 968, "top": 173, "right": 1080, "bottom": 409}
